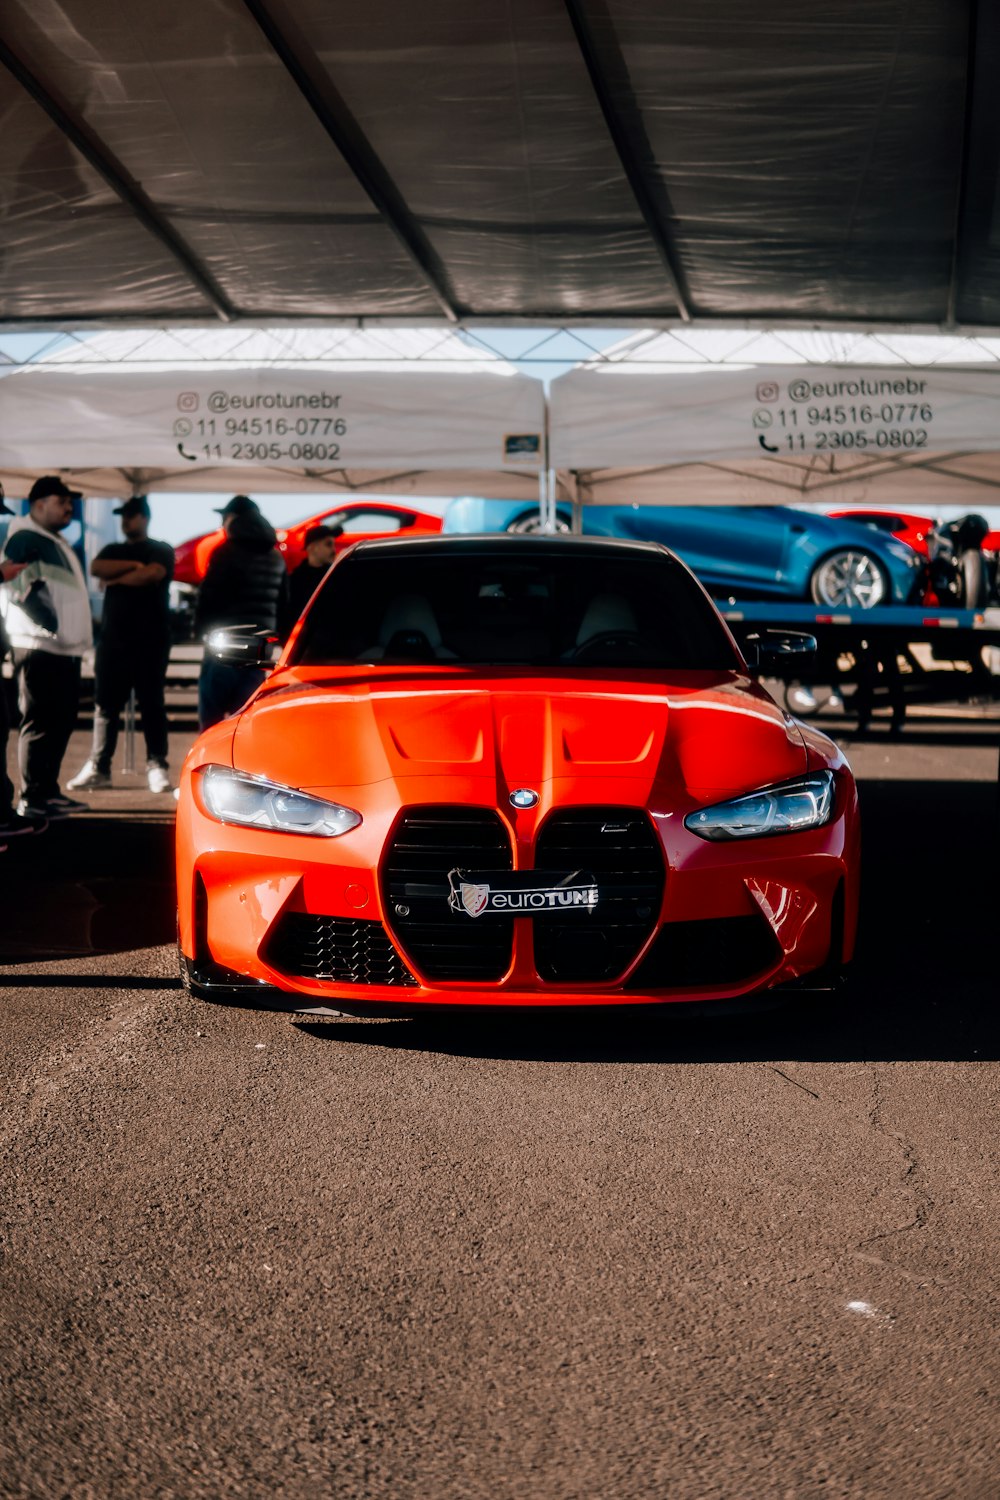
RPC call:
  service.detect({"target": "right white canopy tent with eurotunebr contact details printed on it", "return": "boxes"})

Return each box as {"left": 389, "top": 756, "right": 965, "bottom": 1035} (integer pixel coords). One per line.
{"left": 550, "top": 329, "right": 1000, "bottom": 512}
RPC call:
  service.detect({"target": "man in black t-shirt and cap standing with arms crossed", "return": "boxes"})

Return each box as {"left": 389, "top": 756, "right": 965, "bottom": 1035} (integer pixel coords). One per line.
{"left": 69, "top": 495, "right": 174, "bottom": 792}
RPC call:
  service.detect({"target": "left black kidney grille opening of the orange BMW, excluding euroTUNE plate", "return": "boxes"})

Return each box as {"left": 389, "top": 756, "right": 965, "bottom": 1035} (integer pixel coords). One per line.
{"left": 382, "top": 806, "right": 514, "bottom": 983}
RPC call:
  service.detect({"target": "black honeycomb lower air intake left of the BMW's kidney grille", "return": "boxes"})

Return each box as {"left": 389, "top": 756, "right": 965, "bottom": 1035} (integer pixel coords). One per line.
{"left": 267, "top": 912, "right": 417, "bottom": 984}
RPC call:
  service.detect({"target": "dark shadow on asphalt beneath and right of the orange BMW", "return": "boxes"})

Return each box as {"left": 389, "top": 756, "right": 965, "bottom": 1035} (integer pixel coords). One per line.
{"left": 297, "top": 780, "right": 1000, "bottom": 1062}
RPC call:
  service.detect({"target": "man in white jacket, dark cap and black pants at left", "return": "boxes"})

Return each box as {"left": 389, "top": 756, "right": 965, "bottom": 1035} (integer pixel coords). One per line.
{"left": 3, "top": 474, "right": 93, "bottom": 818}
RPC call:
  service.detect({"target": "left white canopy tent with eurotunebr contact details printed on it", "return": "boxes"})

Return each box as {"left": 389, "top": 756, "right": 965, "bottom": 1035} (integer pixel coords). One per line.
{"left": 0, "top": 329, "right": 546, "bottom": 500}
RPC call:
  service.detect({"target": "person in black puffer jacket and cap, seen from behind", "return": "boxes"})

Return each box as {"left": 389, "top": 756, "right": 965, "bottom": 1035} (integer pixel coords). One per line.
{"left": 195, "top": 495, "right": 288, "bottom": 729}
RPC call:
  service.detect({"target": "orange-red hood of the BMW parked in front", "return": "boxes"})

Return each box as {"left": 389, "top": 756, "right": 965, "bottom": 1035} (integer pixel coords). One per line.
{"left": 232, "top": 668, "right": 808, "bottom": 803}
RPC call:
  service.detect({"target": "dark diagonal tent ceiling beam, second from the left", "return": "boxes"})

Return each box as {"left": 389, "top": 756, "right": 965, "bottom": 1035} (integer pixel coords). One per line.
{"left": 243, "top": 0, "right": 462, "bottom": 324}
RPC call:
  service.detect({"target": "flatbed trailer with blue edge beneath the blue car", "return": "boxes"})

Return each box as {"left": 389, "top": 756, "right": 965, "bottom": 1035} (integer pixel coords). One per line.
{"left": 717, "top": 600, "right": 1000, "bottom": 734}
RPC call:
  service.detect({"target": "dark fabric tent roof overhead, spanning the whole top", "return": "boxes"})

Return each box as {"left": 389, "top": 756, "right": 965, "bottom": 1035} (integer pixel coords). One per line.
{"left": 0, "top": 0, "right": 1000, "bottom": 329}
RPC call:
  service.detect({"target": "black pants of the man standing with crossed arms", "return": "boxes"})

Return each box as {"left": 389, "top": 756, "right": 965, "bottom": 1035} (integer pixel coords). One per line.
{"left": 90, "top": 636, "right": 169, "bottom": 774}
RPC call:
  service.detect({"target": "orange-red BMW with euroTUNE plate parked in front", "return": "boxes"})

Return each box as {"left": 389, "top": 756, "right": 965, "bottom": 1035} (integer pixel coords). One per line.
{"left": 177, "top": 536, "right": 859, "bottom": 1014}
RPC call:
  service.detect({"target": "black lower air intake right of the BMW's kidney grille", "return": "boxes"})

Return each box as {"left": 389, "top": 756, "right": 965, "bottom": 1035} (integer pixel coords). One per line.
{"left": 625, "top": 912, "right": 781, "bottom": 990}
